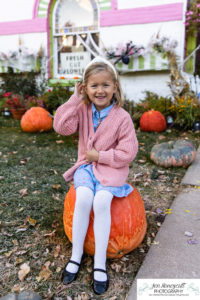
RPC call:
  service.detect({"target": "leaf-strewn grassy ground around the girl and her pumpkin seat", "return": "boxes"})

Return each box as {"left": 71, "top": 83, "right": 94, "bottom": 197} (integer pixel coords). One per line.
{"left": 0, "top": 119, "right": 199, "bottom": 300}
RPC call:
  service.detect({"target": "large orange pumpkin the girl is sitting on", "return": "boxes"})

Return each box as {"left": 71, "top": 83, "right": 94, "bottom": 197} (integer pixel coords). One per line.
{"left": 63, "top": 186, "right": 147, "bottom": 258}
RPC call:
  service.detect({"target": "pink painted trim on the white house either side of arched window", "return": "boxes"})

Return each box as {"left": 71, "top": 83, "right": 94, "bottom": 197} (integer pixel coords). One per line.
{"left": 0, "top": 0, "right": 183, "bottom": 35}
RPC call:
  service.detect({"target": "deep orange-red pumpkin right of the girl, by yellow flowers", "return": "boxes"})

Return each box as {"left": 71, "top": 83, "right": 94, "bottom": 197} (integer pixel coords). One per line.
{"left": 140, "top": 110, "right": 167, "bottom": 132}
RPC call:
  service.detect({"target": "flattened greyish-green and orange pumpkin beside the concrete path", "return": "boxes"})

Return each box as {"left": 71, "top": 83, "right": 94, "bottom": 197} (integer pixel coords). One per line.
{"left": 150, "top": 140, "right": 196, "bottom": 168}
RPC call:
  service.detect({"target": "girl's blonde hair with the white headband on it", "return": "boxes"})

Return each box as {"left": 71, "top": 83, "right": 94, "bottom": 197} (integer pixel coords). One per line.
{"left": 83, "top": 62, "right": 124, "bottom": 107}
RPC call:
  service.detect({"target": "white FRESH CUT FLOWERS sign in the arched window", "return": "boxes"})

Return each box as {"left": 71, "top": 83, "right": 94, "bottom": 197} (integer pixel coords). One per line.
{"left": 60, "top": 52, "right": 91, "bottom": 75}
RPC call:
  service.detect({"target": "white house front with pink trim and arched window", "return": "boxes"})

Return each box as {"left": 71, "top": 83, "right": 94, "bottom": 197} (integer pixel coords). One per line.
{"left": 0, "top": 0, "right": 187, "bottom": 101}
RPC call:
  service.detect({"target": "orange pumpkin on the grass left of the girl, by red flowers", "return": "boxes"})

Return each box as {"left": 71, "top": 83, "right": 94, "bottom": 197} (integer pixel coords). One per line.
{"left": 21, "top": 107, "right": 53, "bottom": 132}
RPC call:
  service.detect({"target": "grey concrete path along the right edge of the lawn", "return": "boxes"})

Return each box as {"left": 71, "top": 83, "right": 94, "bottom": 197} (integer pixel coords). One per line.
{"left": 127, "top": 148, "right": 200, "bottom": 300}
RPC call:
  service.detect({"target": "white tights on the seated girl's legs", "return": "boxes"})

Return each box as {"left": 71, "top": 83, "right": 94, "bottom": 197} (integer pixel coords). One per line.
{"left": 66, "top": 186, "right": 113, "bottom": 281}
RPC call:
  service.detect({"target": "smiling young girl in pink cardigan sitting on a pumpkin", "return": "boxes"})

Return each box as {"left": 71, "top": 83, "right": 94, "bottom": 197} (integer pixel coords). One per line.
{"left": 54, "top": 57, "right": 138, "bottom": 294}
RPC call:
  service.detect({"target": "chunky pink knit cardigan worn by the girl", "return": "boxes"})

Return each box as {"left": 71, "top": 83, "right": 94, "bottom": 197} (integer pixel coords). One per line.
{"left": 53, "top": 95, "right": 138, "bottom": 186}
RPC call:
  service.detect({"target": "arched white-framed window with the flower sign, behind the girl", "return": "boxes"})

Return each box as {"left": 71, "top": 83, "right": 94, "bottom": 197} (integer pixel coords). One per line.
{"left": 53, "top": 0, "right": 100, "bottom": 78}
